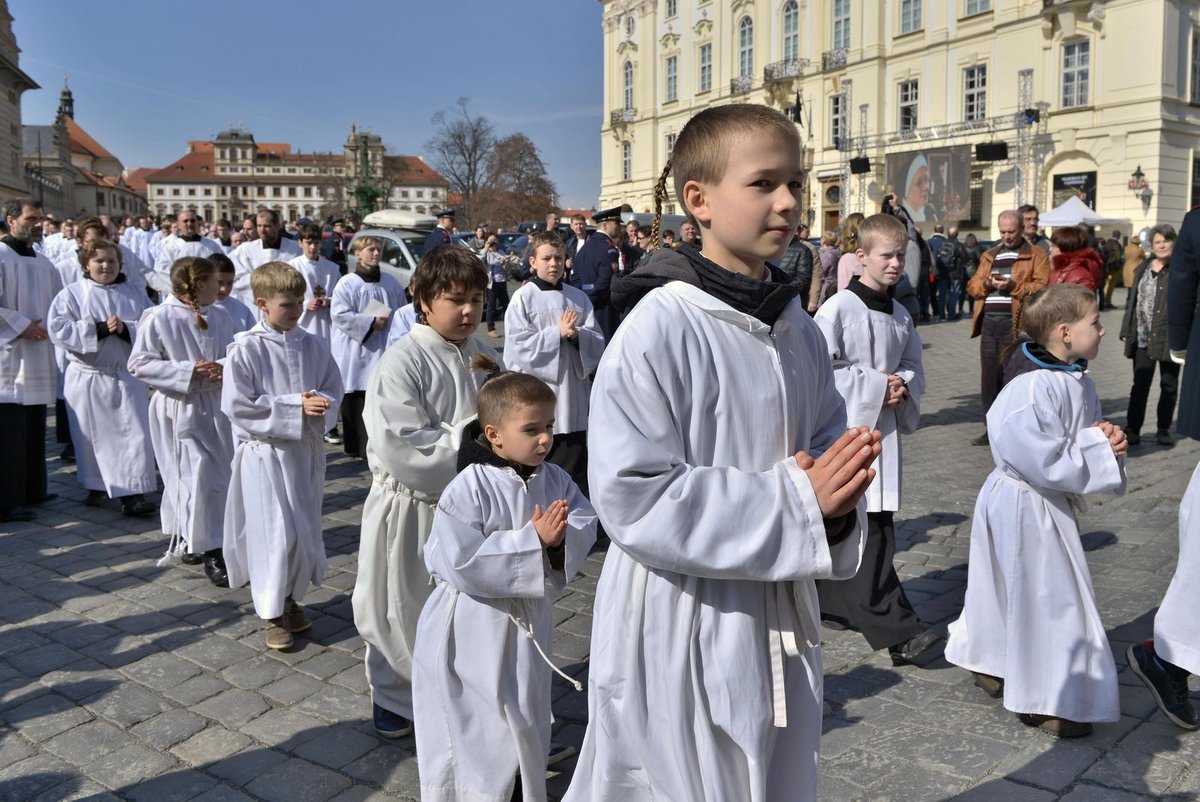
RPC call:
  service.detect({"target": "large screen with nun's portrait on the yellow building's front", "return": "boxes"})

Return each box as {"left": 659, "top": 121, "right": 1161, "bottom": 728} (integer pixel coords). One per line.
{"left": 884, "top": 145, "right": 971, "bottom": 225}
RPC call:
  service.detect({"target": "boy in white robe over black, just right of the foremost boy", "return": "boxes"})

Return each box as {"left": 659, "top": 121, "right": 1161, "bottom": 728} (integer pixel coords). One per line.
{"left": 815, "top": 215, "right": 941, "bottom": 665}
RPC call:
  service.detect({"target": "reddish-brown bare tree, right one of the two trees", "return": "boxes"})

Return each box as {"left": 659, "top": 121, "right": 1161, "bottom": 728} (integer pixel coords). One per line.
{"left": 475, "top": 133, "right": 558, "bottom": 226}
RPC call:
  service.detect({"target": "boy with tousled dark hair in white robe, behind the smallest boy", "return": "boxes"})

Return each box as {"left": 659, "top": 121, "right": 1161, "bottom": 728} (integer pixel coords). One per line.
{"left": 350, "top": 246, "right": 499, "bottom": 738}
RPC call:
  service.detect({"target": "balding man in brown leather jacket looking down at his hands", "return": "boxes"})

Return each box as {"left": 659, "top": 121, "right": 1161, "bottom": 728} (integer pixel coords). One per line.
{"left": 967, "top": 210, "right": 1050, "bottom": 445}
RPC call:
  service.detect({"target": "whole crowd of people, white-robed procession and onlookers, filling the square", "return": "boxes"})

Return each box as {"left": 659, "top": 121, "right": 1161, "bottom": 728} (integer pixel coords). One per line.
{"left": 0, "top": 104, "right": 1200, "bottom": 800}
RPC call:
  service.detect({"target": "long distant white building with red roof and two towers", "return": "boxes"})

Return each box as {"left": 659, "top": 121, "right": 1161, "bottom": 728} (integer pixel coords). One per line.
{"left": 147, "top": 125, "right": 448, "bottom": 222}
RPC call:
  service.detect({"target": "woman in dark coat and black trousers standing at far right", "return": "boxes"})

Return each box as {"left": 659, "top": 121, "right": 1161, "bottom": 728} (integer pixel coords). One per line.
{"left": 1121, "top": 225, "right": 1180, "bottom": 445}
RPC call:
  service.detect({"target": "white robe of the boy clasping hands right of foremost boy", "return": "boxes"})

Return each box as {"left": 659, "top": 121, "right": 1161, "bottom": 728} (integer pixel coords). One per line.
{"left": 814, "top": 291, "right": 925, "bottom": 513}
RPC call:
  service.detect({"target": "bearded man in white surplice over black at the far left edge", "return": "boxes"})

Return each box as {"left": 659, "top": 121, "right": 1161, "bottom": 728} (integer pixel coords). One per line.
{"left": 0, "top": 198, "right": 62, "bottom": 522}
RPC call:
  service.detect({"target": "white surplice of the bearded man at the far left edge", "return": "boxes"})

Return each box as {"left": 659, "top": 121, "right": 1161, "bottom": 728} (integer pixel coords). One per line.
{"left": 0, "top": 243, "right": 62, "bottom": 406}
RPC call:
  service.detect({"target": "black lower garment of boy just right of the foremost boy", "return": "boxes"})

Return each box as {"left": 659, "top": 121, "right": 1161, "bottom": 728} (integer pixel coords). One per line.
{"left": 817, "top": 513, "right": 925, "bottom": 650}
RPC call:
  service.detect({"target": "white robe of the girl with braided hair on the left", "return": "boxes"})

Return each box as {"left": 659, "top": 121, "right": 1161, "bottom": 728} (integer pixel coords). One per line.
{"left": 130, "top": 295, "right": 234, "bottom": 553}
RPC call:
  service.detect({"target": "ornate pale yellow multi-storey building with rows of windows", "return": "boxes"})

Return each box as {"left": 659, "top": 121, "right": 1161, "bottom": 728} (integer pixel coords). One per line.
{"left": 599, "top": 0, "right": 1200, "bottom": 234}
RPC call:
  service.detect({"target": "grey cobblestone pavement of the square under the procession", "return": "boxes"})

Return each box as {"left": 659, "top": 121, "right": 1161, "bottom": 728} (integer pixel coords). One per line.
{"left": 0, "top": 289, "right": 1200, "bottom": 802}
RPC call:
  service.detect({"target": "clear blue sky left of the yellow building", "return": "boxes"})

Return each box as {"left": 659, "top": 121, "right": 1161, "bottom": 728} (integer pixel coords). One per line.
{"left": 8, "top": 0, "right": 604, "bottom": 208}
